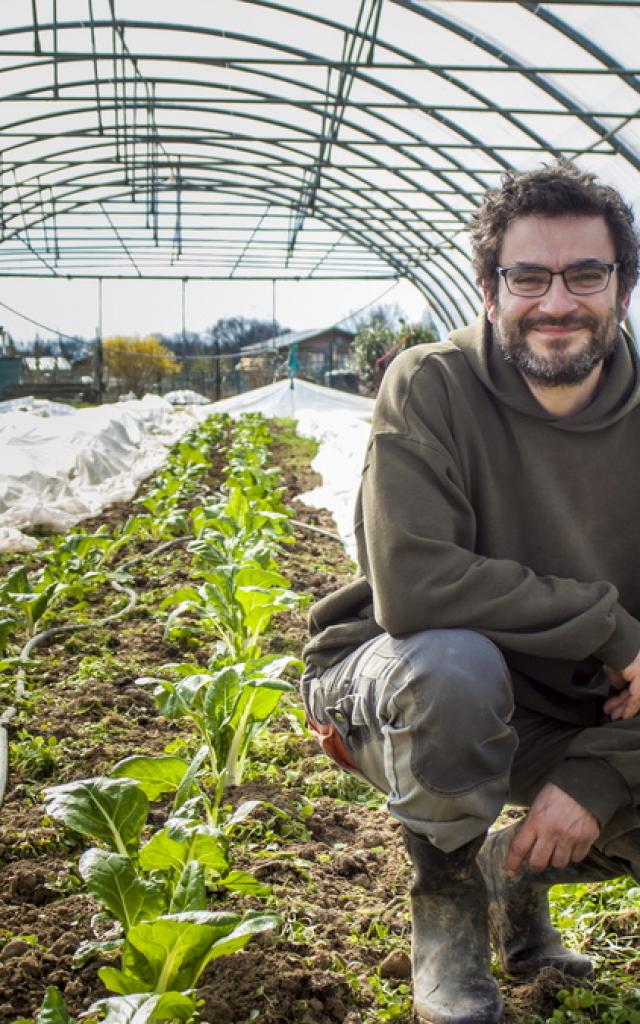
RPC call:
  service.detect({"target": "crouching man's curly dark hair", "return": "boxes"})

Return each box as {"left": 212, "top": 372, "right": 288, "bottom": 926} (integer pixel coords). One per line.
{"left": 469, "top": 163, "right": 639, "bottom": 298}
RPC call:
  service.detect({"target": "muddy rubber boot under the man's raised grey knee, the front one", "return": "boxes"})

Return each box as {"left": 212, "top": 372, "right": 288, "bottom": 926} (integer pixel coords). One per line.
{"left": 403, "top": 828, "right": 503, "bottom": 1024}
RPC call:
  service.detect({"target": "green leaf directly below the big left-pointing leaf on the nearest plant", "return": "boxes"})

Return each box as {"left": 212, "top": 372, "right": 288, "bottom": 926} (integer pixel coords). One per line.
{"left": 79, "top": 849, "right": 167, "bottom": 935}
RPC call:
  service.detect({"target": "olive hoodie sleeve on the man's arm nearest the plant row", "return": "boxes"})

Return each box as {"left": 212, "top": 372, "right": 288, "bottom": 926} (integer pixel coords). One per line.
{"left": 356, "top": 364, "right": 640, "bottom": 668}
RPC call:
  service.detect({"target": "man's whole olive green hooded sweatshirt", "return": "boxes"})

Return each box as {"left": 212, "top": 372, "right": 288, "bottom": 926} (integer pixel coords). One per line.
{"left": 305, "top": 316, "right": 640, "bottom": 725}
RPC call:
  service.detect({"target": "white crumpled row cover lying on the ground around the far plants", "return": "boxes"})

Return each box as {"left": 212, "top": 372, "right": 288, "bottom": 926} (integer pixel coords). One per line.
{"left": 0, "top": 380, "right": 374, "bottom": 554}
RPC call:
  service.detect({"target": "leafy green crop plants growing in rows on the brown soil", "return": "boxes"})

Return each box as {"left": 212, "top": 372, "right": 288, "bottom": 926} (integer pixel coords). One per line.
{"left": 5, "top": 416, "right": 304, "bottom": 1024}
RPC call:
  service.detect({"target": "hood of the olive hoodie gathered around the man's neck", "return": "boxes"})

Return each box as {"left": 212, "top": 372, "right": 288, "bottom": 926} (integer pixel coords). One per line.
{"left": 449, "top": 312, "right": 640, "bottom": 431}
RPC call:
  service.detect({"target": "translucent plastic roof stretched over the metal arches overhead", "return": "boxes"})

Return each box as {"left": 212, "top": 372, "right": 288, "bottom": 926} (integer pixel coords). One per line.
{"left": 0, "top": 0, "right": 640, "bottom": 328}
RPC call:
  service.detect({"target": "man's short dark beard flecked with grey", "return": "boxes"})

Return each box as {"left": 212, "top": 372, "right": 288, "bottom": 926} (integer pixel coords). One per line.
{"left": 494, "top": 308, "right": 618, "bottom": 387}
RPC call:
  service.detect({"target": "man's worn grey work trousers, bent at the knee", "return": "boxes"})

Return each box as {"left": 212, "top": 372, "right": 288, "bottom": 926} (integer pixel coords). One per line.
{"left": 302, "top": 630, "right": 640, "bottom": 852}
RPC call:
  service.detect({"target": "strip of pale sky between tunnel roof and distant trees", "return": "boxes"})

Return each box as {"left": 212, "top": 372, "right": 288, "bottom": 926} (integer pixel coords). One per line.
{"left": 0, "top": 278, "right": 427, "bottom": 342}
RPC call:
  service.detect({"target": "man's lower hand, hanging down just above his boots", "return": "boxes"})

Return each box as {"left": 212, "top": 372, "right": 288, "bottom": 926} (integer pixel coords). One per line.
{"left": 505, "top": 782, "right": 600, "bottom": 874}
